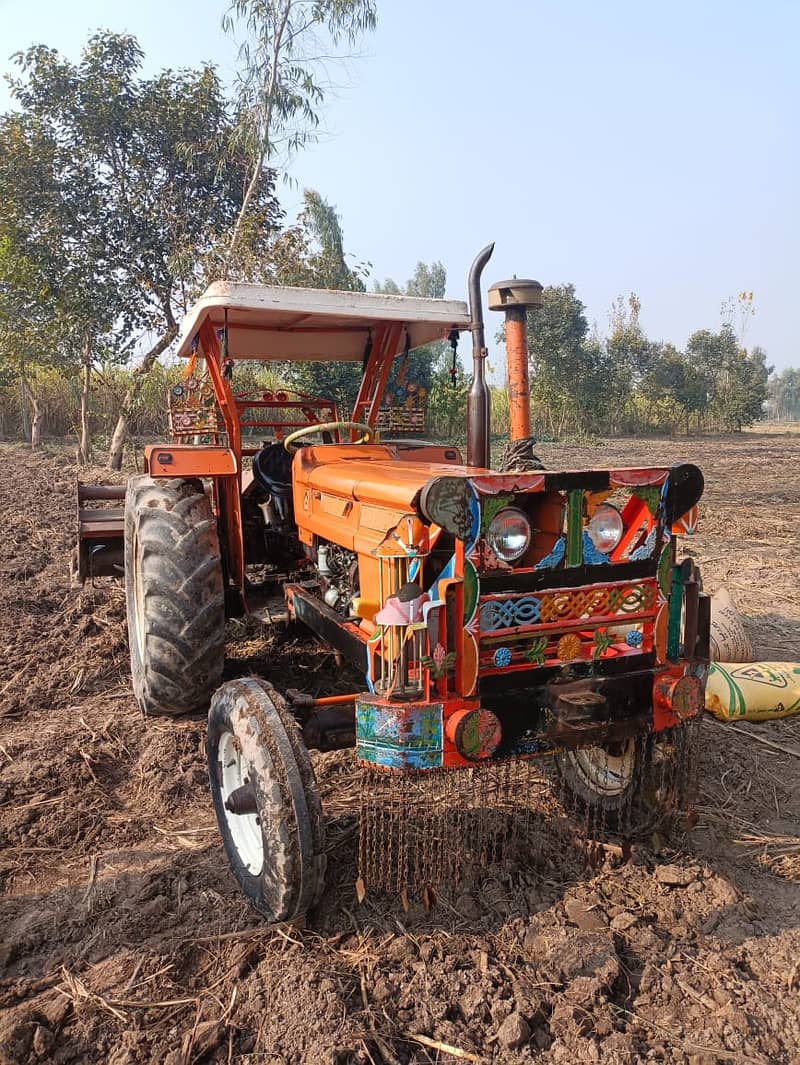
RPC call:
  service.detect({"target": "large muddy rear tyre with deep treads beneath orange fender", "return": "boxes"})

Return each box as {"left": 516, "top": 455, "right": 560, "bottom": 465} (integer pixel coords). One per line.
{"left": 125, "top": 475, "right": 225, "bottom": 715}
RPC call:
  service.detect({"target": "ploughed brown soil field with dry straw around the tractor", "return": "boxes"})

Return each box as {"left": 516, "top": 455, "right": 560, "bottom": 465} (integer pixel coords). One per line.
{"left": 0, "top": 433, "right": 800, "bottom": 1065}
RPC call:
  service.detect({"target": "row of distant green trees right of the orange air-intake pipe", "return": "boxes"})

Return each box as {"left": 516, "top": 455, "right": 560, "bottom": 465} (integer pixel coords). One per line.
{"left": 507, "top": 284, "right": 771, "bottom": 436}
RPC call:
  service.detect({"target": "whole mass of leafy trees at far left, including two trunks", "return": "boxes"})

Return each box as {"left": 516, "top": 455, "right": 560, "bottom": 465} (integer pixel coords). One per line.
{"left": 0, "top": 33, "right": 281, "bottom": 464}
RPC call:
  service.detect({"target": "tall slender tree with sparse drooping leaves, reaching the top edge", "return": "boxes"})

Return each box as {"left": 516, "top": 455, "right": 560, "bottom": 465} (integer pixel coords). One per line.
{"left": 223, "top": 0, "right": 376, "bottom": 268}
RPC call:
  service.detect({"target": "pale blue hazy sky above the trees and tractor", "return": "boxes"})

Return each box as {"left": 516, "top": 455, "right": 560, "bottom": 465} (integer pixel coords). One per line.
{"left": 0, "top": 0, "right": 800, "bottom": 370}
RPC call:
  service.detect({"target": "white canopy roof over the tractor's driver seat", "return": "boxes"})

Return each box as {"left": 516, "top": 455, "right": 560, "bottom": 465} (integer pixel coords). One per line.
{"left": 178, "top": 281, "right": 470, "bottom": 362}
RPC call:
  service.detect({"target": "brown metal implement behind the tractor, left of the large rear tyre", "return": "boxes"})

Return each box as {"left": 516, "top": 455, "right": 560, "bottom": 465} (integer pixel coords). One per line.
{"left": 71, "top": 481, "right": 126, "bottom": 584}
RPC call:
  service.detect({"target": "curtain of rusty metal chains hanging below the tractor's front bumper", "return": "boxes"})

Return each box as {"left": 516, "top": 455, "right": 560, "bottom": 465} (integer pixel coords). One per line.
{"left": 358, "top": 720, "right": 700, "bottom": 895}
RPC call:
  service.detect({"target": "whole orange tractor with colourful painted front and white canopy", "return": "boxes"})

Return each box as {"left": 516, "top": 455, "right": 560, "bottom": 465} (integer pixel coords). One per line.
{"left": 79, "top": 246, "right": 709, "bottom": 920}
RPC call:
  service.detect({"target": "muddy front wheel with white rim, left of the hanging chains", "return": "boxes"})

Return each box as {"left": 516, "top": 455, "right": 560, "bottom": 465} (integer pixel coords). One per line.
{"left": 206, "top": 677, "right": 326, "bottom": 921}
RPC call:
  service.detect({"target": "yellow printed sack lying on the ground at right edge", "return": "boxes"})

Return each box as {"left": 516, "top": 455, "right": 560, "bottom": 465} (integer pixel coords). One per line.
{"left": 705, "top": 662, "right": 800, "bottom": 721}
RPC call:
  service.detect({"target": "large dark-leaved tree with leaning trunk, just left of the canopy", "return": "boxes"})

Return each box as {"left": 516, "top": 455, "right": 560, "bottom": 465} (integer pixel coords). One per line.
{"left": 2, "top": 33, "right": 280, "bottom": 468}
